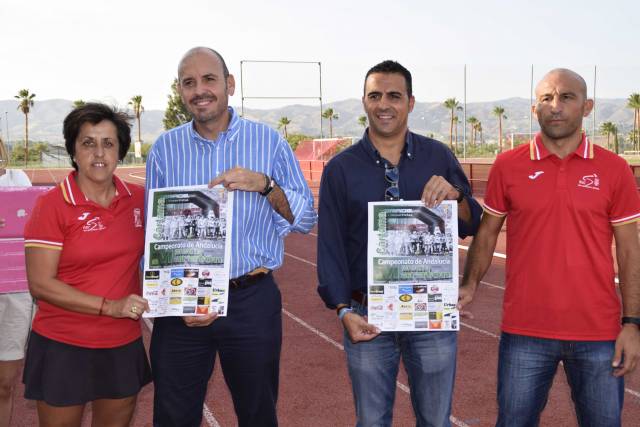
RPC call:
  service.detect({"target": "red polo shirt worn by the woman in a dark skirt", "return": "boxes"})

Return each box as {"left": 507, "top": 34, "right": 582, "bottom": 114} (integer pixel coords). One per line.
{"left": 25, "top": 172, "right": 144, "bottom": 348}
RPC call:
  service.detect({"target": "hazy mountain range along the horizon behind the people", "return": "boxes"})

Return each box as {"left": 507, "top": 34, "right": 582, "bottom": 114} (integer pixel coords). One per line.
{"left": 0, "top": 98, "right": 633, "bottom": 144}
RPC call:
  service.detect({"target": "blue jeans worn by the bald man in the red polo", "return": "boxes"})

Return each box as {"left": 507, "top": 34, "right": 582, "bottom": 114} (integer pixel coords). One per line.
{"left": 496, "top": 332, "right": 624, "bottom": 427}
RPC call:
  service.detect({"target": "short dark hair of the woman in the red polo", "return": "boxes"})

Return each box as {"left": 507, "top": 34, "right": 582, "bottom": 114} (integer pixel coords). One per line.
{"left": 62, "top": 102, "right": 131, "bottom": 170}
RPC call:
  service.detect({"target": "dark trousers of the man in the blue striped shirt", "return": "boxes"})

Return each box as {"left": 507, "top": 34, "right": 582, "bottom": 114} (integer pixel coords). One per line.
{"left": 150, "top": 275, "right": 282, "bottom": 427}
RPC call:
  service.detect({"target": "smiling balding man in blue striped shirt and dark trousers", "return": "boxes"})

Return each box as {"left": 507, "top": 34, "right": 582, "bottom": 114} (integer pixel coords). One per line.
{"left": 146, "top": 47, "right": 317, "bottom": 426}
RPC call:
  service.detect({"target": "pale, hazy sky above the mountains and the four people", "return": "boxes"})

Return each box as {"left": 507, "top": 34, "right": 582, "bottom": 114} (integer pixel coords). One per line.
{"left": 0, "top": 0, "right": 640, "bottom": 109}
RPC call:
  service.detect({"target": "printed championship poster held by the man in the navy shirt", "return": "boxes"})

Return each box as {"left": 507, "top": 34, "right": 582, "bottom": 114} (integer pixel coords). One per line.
{"left": 367, "top": 200, "right": 460, "bottom": 331}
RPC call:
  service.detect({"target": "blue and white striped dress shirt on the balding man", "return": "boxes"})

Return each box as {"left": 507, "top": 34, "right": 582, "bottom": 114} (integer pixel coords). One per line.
{"left": 146, "top": 107, "right": 317, "bottom": 277}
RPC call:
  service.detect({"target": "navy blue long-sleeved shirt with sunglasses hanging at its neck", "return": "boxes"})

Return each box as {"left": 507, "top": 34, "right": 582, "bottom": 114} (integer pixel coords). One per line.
{"left": 318, "top": 131, "right": 482, "bottom": 308}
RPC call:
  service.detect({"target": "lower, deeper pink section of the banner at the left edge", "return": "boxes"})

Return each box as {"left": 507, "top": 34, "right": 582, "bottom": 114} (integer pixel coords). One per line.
{"left": 0, "top": 239, "right": 29, "bottom": 294}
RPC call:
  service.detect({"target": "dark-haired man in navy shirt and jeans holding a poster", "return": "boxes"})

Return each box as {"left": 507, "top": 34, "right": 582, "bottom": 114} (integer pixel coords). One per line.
{"left": 318, "top": 61, "right": 482, "bottom": 427}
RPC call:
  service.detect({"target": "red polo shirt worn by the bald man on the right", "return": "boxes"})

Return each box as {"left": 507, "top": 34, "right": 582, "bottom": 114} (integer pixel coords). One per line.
{"left": 484, "top": 135, "right": 640, "bottom": 341}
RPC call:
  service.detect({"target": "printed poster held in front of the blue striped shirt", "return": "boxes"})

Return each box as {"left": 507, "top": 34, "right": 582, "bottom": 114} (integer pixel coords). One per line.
{"left": 142, "top": 185, "right": 233, "bottom": 317}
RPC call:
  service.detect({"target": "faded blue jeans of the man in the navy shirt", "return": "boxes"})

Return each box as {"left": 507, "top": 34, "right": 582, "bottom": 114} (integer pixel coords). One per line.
{"left": 344, "top": 304, "right": 457, "bottom": 427}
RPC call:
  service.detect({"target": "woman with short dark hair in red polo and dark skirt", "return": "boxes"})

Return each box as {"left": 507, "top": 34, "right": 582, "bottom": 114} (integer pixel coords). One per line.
{"left": 24, "top": 103, "right": 151, "bottom": 426}
